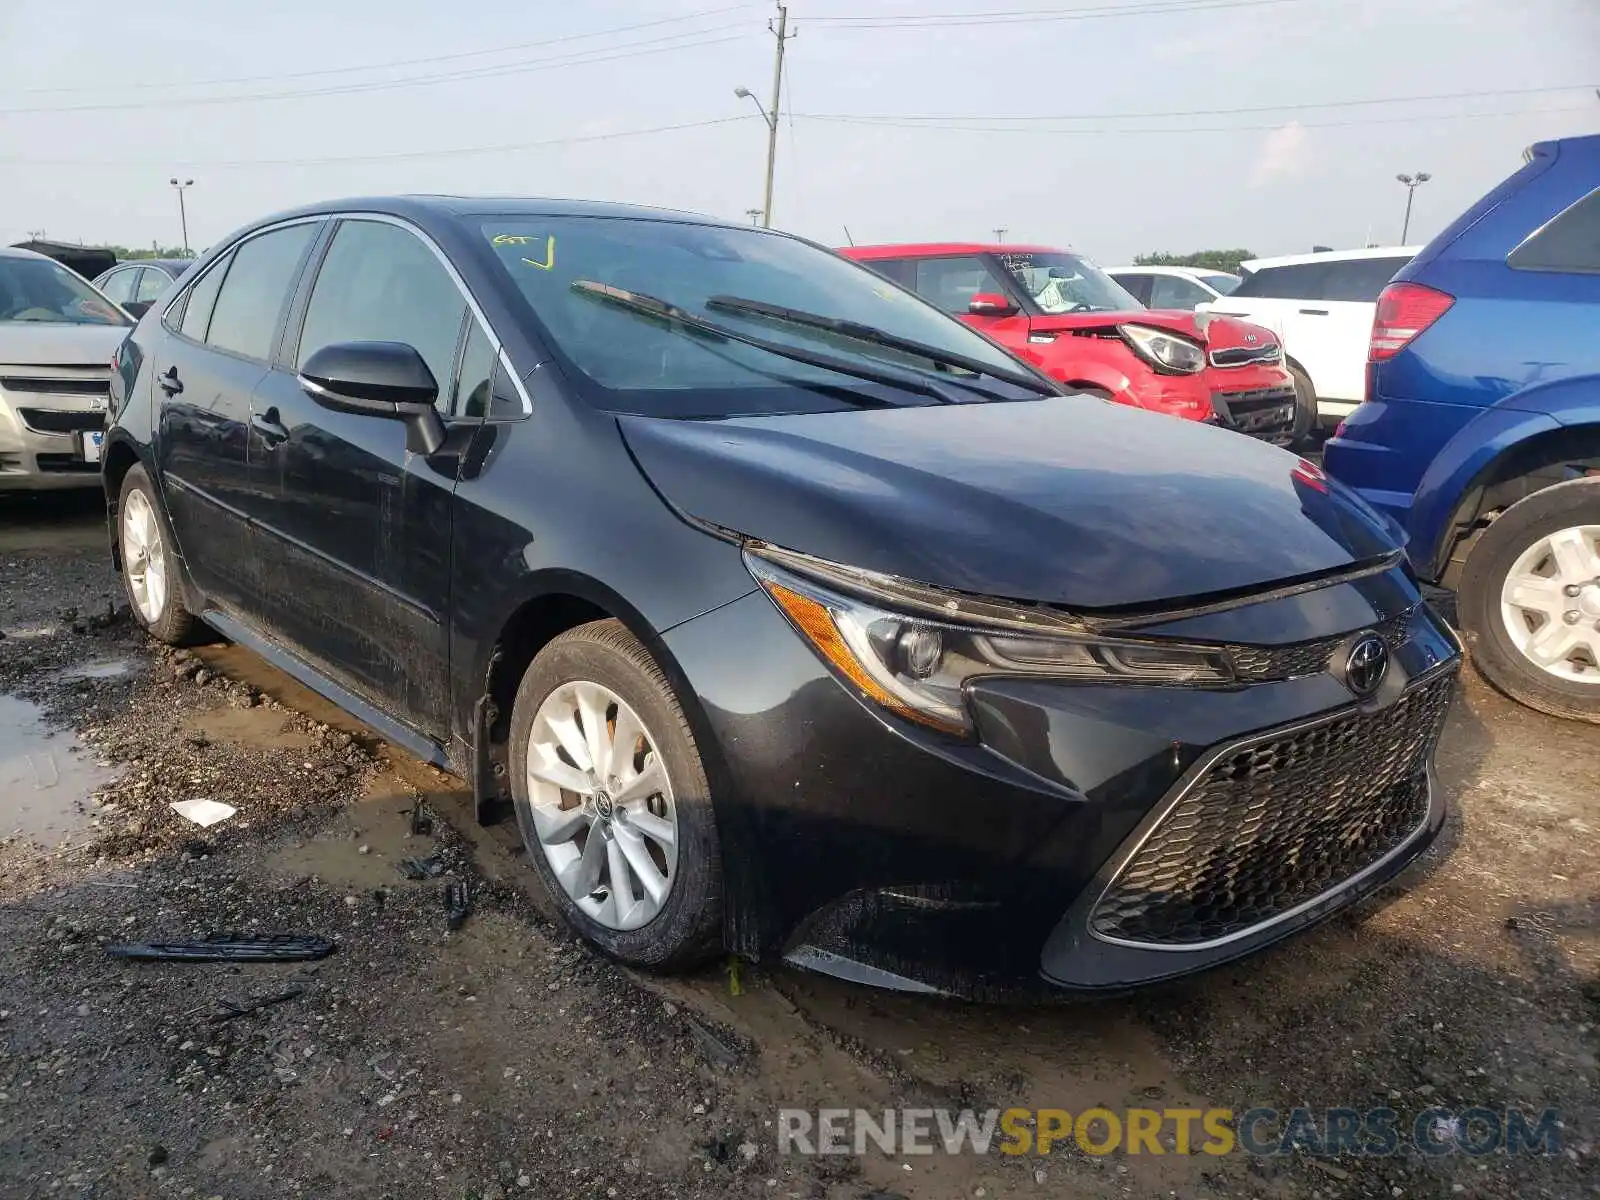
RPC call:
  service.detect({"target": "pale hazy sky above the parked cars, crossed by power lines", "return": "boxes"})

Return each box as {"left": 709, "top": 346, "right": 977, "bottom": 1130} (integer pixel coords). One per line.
{"left": 0, "top": 0, "right": 1600, "bottom": 262}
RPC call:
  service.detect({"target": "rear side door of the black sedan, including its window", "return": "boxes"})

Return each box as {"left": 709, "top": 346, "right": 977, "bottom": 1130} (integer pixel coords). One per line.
{"left": 152, "top": 222, "right": 318, "bottom": 613}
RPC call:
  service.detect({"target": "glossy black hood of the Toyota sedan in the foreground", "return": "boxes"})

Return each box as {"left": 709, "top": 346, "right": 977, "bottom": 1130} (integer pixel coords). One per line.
{"left": 618, "top": 397, "right": 1398, "bottom": 608}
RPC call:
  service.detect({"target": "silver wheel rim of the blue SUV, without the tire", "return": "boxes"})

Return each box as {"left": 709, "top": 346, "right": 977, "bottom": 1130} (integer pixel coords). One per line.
{"left": 1501, "top": 525, "right": 1600, "bottom": 686}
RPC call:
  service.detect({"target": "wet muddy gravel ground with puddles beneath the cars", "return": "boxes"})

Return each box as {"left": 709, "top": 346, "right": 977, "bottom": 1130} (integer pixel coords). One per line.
{"left": 0, "top": 498, "right": 1600, "bottom": 1200}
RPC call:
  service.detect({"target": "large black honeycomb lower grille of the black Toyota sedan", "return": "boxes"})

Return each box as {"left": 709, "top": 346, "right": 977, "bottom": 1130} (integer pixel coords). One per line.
{"left": 1090, "top": 670, "right": 1456, "bottom": 947}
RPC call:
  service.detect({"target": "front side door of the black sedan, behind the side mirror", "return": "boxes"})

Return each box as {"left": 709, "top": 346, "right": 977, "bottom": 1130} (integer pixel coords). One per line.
{"left": 250, "top": 219, "right": 480, "bottom": 739}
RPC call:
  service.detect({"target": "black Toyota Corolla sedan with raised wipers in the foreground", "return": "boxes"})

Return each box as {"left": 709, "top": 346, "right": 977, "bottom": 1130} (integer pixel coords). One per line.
{"left": 104, "top": 197, "right": 1459, "bottom": 995}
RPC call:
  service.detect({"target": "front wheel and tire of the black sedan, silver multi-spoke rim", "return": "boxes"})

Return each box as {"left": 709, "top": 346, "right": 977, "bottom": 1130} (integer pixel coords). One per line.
{"left": 510, "top": 621, "right": 722, "bottom": 971}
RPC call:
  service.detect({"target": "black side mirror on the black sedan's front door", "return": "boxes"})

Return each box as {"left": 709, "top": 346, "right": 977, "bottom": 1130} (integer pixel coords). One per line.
{"left": 299, "top": 342, "right": 445, "bottom": 454}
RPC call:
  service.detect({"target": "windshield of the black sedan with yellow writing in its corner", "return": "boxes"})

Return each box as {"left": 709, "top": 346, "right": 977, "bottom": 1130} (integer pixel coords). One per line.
{"left": 482, "top": 216, "right": 1029, "bottom": 418}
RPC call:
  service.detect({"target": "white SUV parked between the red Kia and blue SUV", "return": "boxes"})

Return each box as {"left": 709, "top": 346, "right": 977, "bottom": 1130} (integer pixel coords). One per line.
{"left": 1206, "top": 246, "right": 1419, "bottom": 424}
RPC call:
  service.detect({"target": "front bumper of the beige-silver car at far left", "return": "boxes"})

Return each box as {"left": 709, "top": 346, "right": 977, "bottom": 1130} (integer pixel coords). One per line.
{"left": 0, "top": 387, "right": 106, "bottom": 491}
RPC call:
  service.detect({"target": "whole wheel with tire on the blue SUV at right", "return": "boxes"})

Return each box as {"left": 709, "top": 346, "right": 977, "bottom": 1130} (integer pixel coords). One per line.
{"left": 1458, "top": 478, "right": 1600, "bottom": 723}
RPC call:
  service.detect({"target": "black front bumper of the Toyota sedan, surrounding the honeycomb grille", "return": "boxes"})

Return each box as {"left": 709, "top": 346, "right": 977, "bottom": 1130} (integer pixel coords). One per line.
{"left": 664, "top": 571, "right": 1459, "bottom": 998}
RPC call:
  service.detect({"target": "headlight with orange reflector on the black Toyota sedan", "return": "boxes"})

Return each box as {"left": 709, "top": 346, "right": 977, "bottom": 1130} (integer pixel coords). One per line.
{"left": 744, "top": 544, "right": 1234, "bottom": 734}
